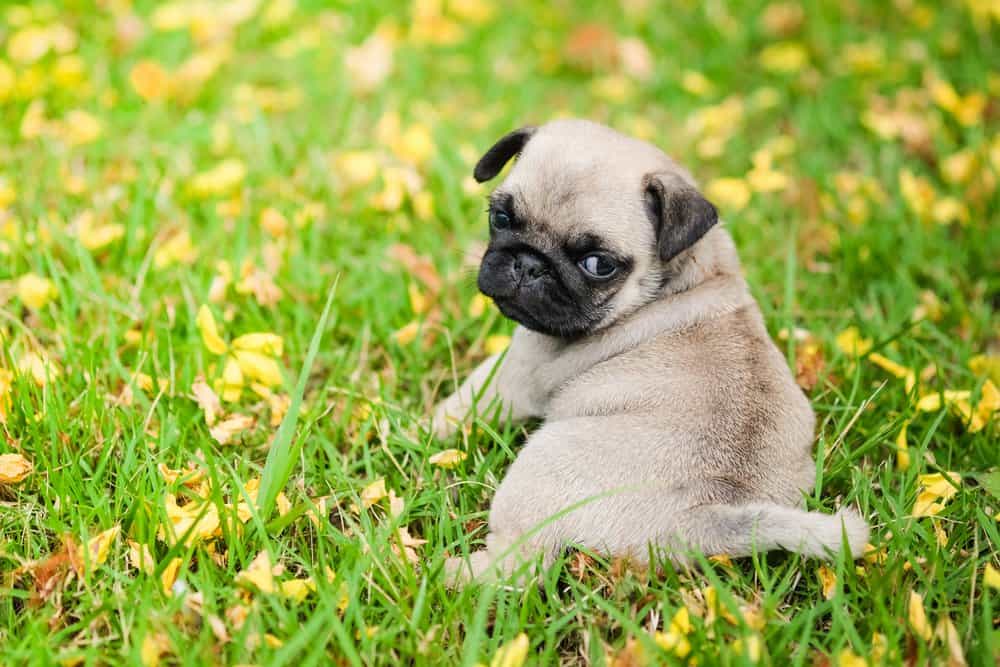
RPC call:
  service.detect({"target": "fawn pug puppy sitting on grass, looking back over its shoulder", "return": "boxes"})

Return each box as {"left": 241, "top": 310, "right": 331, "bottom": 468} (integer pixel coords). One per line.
{"left": 433, "top": 120, "right": 868, "bottom": 584}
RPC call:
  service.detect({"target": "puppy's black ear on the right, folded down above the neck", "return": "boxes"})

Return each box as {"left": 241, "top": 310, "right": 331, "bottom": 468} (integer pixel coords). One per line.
{"left": 645, "top": 174, "right": 719, "bottom": 262}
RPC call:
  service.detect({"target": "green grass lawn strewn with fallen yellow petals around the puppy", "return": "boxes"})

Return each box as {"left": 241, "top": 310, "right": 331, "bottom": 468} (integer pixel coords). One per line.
{"left": 0, "top": 0, "right": 1000, "bottom": 667}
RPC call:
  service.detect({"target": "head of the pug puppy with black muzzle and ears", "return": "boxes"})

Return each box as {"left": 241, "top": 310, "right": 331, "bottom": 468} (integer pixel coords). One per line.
{"left": 474, "top": 120, "right": 718, "bottom": 338}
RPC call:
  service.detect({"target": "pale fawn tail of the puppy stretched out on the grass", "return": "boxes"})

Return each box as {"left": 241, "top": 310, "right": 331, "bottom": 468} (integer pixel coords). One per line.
{"left": 680, "top": 503, "right": 869, "bottom": 558}
